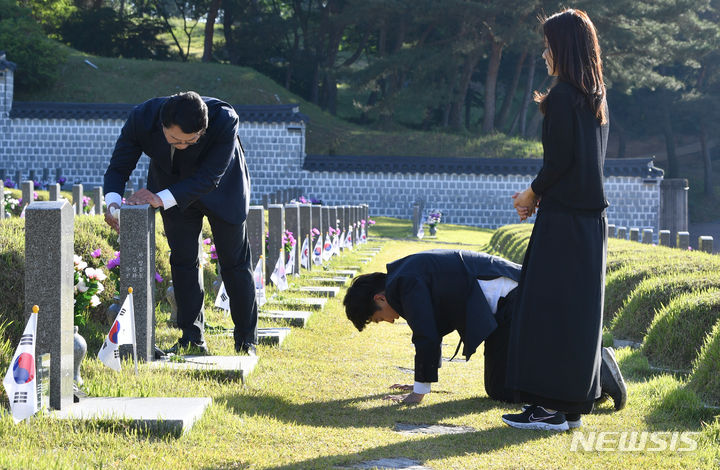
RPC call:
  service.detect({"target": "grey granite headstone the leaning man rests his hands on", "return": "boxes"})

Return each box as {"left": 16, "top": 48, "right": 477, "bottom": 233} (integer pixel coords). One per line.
{"left": 120, "top": 204, "right": 155, "bottom": 362}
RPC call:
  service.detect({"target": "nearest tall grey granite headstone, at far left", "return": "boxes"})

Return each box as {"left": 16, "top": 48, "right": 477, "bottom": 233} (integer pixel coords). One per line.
{"left": 25, "top": 200, "right": 75, "bottom": 410}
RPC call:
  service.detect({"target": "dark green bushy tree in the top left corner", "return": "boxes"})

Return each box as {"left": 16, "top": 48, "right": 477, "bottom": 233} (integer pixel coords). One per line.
{"left": 0, "top": 0, "right": 65, "bottom": 91}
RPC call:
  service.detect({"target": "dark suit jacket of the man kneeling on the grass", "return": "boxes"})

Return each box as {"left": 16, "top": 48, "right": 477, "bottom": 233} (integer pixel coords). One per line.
{"left": 385, "top": 250, "right": 521, "bottom": 382}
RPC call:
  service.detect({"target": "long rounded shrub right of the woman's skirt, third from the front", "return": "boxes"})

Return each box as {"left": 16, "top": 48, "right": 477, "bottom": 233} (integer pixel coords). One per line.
{"left": 611, "top": 271, "right": 720, "bottom": 341}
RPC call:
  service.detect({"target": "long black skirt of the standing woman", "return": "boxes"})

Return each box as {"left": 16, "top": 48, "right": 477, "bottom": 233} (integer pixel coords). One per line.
{"left": 507, "top": 201, "right": 607, "bottom": 413}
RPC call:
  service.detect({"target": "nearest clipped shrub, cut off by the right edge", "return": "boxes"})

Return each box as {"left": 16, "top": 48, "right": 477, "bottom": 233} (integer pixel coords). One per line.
{"left": 688, "top": 322, "right": 720, "bottom": 406}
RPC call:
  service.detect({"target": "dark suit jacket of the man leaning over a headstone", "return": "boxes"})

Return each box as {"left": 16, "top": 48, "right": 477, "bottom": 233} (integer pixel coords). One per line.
{"left": 103, "top": 97, "right": 250, "bottom": 224}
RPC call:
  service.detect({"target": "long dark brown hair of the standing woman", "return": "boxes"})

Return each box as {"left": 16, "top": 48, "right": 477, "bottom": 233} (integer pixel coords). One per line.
{"left": 535, "top": 8, "right": 607, "bottom": 124}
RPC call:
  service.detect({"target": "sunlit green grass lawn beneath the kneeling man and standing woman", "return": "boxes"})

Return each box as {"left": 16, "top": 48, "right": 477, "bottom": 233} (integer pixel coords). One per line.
{"left": 0, "top": 223, "right": 720, "bottom": 469}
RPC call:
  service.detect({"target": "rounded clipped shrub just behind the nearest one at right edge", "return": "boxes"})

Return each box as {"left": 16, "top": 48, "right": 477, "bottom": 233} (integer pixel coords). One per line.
{"left": 642, "top": 289, "right": 720, "bottom": 369}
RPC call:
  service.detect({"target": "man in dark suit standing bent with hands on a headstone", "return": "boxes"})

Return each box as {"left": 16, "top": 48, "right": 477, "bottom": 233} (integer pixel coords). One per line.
{"left": 104, "top": 91, "right": 257, "bottom": 354}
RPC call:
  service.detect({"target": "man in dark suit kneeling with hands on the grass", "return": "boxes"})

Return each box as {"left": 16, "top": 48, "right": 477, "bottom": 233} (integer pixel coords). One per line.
{"left": 343, "top": 250, "right": 627, "bottom": 414}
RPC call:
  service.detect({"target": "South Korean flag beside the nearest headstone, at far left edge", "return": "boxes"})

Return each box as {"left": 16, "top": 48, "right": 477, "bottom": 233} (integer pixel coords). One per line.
{"left": 3, "top": 305, "right": 39, "bottom": 423}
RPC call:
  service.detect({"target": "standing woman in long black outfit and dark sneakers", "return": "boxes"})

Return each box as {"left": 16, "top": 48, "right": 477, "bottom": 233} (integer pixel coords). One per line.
{"left": 503, "top": 9, "right": 609, "bottom": 430}
